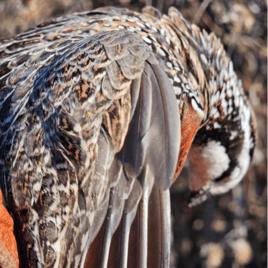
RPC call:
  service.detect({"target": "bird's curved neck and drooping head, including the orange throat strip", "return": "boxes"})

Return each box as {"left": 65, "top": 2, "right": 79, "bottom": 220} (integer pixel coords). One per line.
{"left": 164, "top": 8, "right": 256, "bottom": 206}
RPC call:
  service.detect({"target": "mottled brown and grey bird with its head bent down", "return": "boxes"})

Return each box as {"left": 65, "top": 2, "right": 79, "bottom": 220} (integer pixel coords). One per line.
{"left": 0, "top": 6, "right": 257, "bottom": 268}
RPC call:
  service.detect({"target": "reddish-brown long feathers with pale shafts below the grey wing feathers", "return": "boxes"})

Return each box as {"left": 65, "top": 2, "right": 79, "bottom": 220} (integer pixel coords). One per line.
{"left": 84, "top": 186, "right": 171, "bottom": 268}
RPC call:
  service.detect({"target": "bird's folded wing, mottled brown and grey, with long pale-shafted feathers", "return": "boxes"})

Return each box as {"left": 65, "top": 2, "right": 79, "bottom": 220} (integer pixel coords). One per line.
{"left": 0, "top": 21, "right": 180, "bottom": 267}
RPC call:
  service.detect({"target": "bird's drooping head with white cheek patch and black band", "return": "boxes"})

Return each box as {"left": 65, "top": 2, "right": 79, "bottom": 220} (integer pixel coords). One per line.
{"left": 188, "top": 79, "right": 256, "bottom": 206}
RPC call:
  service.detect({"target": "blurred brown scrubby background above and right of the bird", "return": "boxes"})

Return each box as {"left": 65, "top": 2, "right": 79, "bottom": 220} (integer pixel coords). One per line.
{"left": 0, "top": 0, "right": 268, "bottom": 268}
